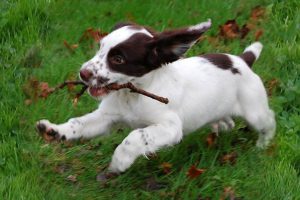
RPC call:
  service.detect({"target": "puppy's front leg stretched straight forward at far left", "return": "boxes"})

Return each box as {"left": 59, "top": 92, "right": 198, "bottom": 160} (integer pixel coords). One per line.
{"left": 36, "top": 105, "right": 119, "bottom": 140}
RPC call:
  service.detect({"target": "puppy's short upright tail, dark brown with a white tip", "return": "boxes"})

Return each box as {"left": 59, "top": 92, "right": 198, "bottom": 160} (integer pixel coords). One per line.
{"left": 240, "top": 42, "right": 263, "bottom": 68}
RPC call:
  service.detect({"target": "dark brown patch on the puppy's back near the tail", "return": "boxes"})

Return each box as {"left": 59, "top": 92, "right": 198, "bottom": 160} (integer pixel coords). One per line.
{"left": 200, "top": 53, "right": 240, "bottom": 74}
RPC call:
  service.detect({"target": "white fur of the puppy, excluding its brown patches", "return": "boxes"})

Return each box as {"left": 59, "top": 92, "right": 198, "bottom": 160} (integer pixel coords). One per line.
{"left": 39, "top": 24, "right": 275, "bottom": 172}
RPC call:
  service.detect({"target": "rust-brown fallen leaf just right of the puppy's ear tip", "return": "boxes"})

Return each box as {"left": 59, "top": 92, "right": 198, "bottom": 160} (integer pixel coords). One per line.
{"left": 219, "top": 19, "right": 240, "bottom": 39}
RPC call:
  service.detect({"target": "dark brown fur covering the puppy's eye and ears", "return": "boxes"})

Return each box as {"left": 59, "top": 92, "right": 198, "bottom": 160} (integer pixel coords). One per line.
{"left": 107, "top": 23, "right": 211, "bottom": 77}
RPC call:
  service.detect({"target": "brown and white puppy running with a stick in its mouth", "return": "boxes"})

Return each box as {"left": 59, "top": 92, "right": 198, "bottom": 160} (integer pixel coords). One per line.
{"left": 36, "top": 20, "right": 276, "bottom": 173}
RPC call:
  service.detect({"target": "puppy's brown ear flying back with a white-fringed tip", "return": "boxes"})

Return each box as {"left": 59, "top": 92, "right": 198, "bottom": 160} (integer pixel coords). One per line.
{"left": 149, "top": 19, "right": 211, "bottom": 65}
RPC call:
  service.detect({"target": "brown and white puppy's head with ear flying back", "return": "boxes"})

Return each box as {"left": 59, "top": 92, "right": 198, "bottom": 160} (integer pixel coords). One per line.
{"left": 80, "top": 20, "right": 211, "bottom": 98}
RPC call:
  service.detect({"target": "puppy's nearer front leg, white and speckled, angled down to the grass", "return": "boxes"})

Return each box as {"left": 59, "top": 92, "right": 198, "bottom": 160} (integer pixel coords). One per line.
{"left": 109, "top": 114, "right": 183, "bottom": 173}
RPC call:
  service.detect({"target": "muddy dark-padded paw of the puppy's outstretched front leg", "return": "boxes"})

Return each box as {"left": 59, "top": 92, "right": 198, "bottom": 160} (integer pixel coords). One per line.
{"left": 36, "top": 119, "right": 66, "bottom": 142}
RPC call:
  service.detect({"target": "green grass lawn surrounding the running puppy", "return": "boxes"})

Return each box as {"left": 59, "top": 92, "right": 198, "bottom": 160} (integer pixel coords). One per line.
{"left": 0, "top": 0, "right": 300, "bottom": 200}
